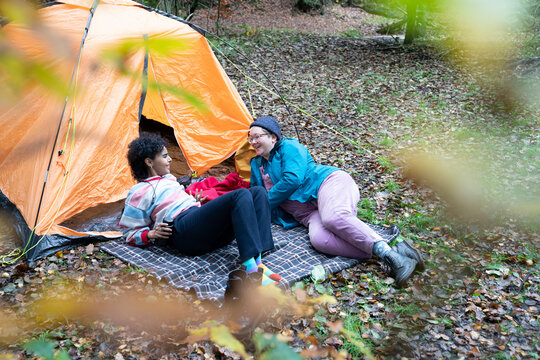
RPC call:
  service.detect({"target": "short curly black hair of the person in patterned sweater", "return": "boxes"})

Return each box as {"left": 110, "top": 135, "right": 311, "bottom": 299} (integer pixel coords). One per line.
{"left": 127, "top": 132, "right": 169, "bottom": 181}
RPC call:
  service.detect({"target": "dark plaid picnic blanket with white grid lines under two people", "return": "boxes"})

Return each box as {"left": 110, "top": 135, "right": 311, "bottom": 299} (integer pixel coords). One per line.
{"left": 100, "top": 224, "right": 400, "bottom": 302}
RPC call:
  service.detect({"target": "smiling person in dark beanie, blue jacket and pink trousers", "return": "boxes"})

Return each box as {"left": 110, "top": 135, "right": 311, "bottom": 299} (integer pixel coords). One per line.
{"left": 248, "top": 116, "right": 424, "bottom": 287}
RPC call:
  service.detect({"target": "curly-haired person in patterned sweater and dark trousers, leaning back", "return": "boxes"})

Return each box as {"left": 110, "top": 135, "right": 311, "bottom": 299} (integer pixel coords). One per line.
{"left": 120, "top": 134, "right": 280, "bottom": 284}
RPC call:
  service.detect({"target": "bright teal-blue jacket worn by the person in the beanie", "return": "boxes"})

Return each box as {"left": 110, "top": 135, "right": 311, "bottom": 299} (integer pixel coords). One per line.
{"left": 250, "top": 138, "right": 339, "bottom": 229}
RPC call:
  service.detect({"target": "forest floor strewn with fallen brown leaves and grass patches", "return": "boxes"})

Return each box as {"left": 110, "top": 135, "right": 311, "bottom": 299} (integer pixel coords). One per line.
{"left": 0, "top": 1, "right": 540, "bottom": 359}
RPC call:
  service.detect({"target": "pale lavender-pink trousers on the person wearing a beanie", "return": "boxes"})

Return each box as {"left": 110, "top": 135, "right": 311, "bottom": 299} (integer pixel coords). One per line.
{"left": 297, "top": 171, "right": 382, "bottom": 259}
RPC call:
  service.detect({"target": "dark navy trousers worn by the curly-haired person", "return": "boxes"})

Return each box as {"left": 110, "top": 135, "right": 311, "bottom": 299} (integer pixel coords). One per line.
{"left": 171, "top": 186, "right": 274, "bottom": 261}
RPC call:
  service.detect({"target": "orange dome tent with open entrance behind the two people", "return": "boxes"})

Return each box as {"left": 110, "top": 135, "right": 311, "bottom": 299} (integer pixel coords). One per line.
{"left": 0, "top": 0, "right": 252, "bottom": 259}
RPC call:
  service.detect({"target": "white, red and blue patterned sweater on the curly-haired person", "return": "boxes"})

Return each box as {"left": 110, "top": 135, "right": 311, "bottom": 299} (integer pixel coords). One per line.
{"left": 120, "top": 174, "right": 201, "bottom": 246}
